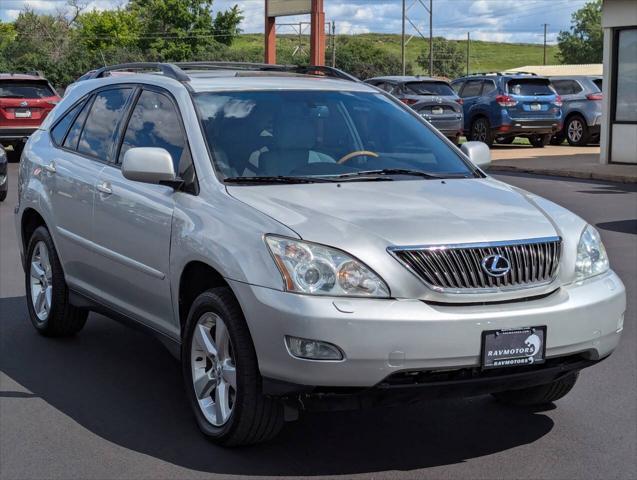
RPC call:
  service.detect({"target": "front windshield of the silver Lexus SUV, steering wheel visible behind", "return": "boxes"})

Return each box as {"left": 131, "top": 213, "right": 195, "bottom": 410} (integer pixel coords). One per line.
{"left": 194, "top": 91, "right": 479, "bottom": 181}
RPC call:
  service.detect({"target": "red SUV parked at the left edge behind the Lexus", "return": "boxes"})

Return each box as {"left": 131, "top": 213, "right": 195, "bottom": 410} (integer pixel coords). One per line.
{"left": 0, "top": 73, "right": 61, "bottom": 160}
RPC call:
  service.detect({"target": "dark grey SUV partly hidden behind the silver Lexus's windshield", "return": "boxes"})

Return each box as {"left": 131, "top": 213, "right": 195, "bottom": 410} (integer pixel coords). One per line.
{"left": 365, "top": 76, "right": 464, "bottom": 144}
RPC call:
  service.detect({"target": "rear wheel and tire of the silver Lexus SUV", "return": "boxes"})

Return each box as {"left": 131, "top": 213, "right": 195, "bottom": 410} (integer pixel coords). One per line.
{"left": 25, "top": 227, "right": 88, "bottom": 337}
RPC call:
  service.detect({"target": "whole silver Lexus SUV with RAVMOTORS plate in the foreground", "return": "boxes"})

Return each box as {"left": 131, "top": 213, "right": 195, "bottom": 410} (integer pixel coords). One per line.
{"left": 15, "top": 63, "right": 625, "bottom": 446}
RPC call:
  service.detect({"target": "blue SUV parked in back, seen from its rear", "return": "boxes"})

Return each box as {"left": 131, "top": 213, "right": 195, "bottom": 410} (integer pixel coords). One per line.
{"left": 451, "top": 72, "right": 562, "bottom": 147}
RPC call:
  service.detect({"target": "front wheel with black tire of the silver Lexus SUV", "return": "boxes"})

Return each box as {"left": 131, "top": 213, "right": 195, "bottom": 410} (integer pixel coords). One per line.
{"left": 181, "top": 287, "right": 283, "bottom": 446}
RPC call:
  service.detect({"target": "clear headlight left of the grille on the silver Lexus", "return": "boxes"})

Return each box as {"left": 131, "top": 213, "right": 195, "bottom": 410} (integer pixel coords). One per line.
{"left": 265, "top": 235, "right": 389, "bottom": 298}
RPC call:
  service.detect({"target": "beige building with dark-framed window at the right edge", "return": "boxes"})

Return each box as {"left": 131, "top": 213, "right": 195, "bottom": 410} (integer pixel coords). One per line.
{"left": 600, "top": 0, "right": 637, "bottom": 164}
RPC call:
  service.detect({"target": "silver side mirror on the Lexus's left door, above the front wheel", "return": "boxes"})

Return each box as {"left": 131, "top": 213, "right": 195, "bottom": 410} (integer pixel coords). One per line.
{"left": 122, "top": 147, "right": 177, "bottom": 184}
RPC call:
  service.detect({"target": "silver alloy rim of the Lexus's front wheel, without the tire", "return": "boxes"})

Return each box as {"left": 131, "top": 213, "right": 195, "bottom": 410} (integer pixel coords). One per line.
{"left": 190, "top": 312, "right": 237, "bottom": 427}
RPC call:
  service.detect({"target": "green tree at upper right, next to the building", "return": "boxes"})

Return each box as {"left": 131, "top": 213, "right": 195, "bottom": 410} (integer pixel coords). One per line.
{"left": 557, "top": 0, "right": 604, "bottom": 64}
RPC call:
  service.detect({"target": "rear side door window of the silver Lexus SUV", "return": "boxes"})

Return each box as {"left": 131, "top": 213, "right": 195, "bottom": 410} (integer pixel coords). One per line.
{"left": 77, "top": 88, "right": 133, "bottom": 162}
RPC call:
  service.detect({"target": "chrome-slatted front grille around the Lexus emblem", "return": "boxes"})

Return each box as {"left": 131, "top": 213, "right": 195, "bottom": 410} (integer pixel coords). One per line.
{"left": 388, "top": 237, "right": 562, "bottom": 292}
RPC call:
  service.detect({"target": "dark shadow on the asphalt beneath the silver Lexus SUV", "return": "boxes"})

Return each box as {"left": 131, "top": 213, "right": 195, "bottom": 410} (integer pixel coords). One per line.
{"left": 0, "top": 297, "right": 553, "bottom": 476}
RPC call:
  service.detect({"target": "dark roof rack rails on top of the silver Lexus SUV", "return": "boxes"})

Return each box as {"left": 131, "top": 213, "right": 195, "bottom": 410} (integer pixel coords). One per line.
{"left": 81, "top": 61, "right": 360, "bottom": 82}
